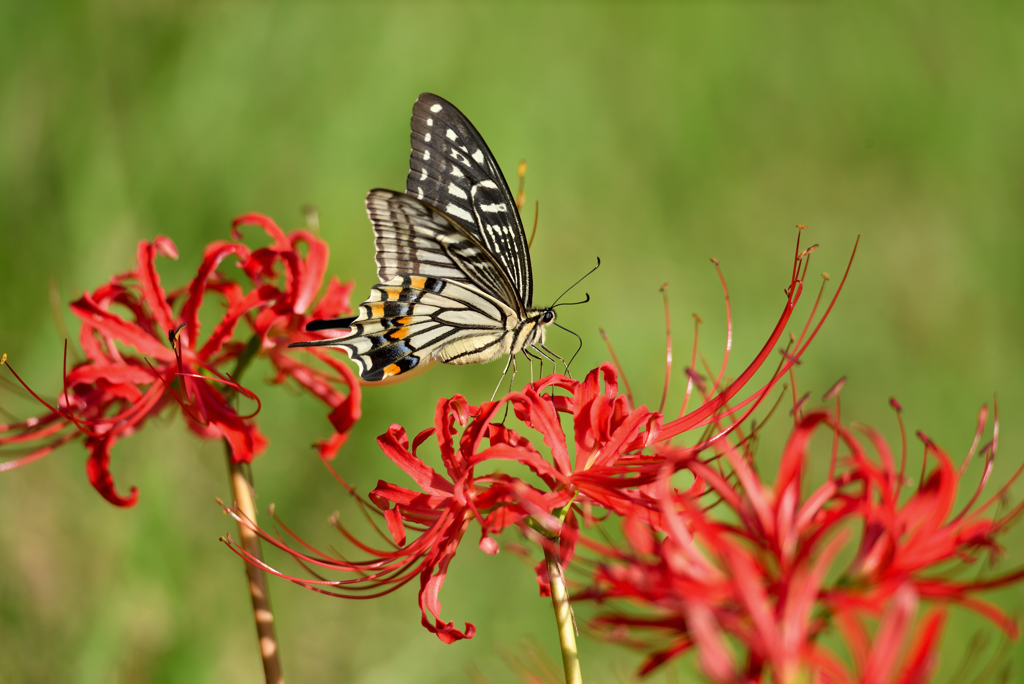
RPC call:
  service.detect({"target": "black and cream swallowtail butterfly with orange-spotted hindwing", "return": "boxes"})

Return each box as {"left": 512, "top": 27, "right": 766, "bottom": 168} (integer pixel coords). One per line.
{"left": 290, "top": 93, "right": 564, "bottom": 391}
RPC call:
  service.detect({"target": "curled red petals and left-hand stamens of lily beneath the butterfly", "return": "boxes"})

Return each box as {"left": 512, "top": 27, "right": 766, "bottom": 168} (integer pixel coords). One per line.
{"left": 221, "top": 365, "right": 660, "bottom": 643}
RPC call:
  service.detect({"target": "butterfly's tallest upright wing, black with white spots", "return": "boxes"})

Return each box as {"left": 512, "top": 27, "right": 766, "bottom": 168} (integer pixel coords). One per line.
{"left": 406, "top": 93, "right": 534, "bottom": 311}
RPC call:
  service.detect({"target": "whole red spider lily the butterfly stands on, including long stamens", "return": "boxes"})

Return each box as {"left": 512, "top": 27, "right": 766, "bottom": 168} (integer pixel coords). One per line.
{"left": 227, "top": 232, "right": 856, "bottom": 643}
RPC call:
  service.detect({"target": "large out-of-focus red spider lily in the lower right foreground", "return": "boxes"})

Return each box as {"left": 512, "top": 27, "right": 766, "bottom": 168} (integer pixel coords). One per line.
{"left": 579, "top": 403, "right": 1024, "bottom": 684}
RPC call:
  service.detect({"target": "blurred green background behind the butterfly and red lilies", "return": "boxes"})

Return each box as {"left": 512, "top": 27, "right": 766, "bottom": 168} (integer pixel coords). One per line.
{"left": 0, "top": 0, "right": 1024, "bottom": 683}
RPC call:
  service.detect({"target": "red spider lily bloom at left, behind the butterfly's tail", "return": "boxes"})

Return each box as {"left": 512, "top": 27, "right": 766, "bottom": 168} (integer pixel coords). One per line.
{"left": 0, "top": 214, "right": 359, "bottom": 506}
